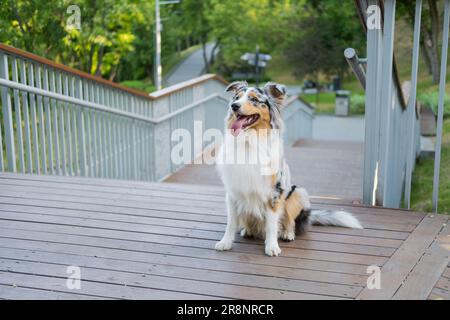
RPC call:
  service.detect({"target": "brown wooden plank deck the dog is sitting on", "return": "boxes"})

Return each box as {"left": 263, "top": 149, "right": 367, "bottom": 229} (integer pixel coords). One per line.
{"left": 0, "top": 174, "right": 450, "bottom": 299}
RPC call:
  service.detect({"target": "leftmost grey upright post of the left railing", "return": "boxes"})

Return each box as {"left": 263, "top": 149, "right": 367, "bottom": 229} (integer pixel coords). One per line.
{"left": 0, "top": 52, "right": 16, "bottom": 172}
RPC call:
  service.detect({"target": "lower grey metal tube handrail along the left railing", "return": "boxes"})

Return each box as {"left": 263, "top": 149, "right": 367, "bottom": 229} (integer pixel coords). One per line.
{"left": 0, "top": 78, "right": 228, "bottom": 124}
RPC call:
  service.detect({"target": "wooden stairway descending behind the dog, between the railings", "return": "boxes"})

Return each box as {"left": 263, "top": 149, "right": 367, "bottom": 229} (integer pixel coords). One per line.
{"left": 165, "top": 139, "right": 363, "bottom": 202}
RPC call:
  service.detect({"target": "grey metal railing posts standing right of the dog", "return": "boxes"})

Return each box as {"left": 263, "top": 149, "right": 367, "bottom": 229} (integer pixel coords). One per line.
{"left": 356, "top": 0, "right": 450, "bottom": 210}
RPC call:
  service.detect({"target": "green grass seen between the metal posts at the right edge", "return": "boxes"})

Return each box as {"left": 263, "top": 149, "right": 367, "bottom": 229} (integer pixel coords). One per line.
{"left": 411, "top": 118, "right": 450, "bottom": 214}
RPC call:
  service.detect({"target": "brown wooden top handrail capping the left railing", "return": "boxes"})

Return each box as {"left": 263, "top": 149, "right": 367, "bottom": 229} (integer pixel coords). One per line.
{"left": 0, "top": 42, "right": 228, "bottom": 100}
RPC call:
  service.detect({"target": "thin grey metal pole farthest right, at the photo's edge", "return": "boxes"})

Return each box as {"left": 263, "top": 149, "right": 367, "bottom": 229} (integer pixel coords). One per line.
{"left": 433, "top": 0, "right": 450, "bottom": 213}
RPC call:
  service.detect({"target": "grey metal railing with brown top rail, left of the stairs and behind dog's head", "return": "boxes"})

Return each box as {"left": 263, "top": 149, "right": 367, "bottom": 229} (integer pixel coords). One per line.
{"left": 0, "top": 44, "right": 312, "bottom": 181}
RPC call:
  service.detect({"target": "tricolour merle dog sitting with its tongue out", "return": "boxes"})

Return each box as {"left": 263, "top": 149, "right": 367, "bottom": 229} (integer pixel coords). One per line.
{"left": 215, "top": 81, "right": 362, "bottom": 256}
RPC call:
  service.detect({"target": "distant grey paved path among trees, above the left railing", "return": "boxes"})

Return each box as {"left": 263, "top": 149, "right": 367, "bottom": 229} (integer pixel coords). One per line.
{"left": 163, "top": 43, "right": 214, "bottom": 86}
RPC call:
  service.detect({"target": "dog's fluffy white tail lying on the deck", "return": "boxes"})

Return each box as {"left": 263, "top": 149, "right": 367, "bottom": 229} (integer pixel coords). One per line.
{"left": 309, "top": 210, "right": 363, "bottom": 229}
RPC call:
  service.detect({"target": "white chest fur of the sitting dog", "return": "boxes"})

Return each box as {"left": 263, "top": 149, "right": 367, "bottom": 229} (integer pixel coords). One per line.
{"left": 217, "top": 133, "right": 282, "bottom": 219}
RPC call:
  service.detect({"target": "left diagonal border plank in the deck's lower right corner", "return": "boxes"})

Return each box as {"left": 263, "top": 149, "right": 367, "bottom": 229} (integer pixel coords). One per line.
{"left": 357, "top": 215, "right": 448, "bottom": 299}
